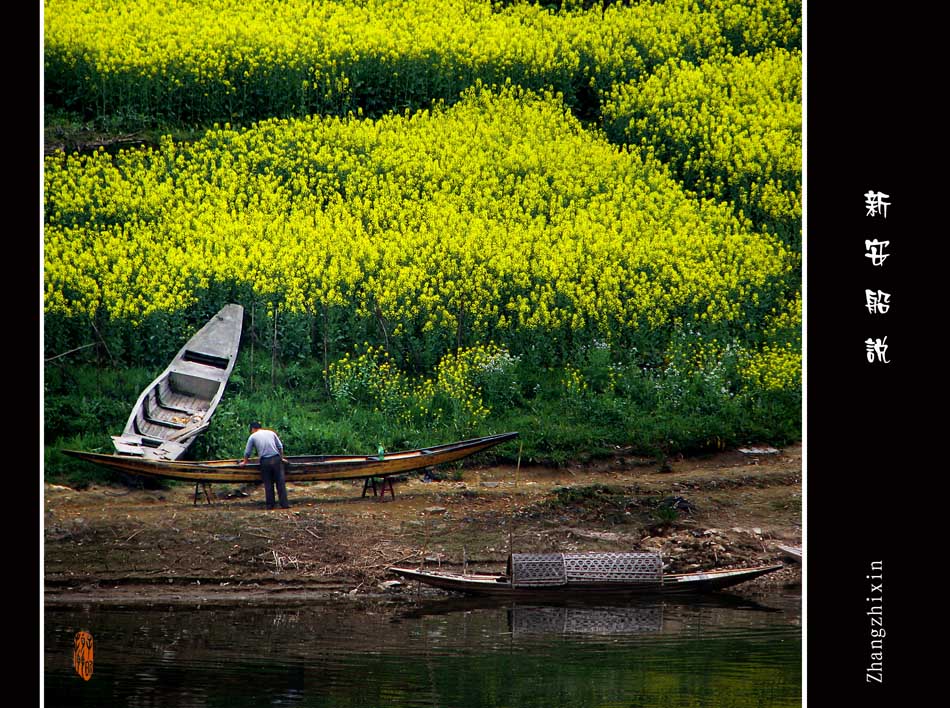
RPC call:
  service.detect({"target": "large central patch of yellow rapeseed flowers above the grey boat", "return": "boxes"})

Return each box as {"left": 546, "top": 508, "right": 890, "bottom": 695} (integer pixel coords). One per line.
{"left": 45, "top": 88, "right": 797, "bottom": 348}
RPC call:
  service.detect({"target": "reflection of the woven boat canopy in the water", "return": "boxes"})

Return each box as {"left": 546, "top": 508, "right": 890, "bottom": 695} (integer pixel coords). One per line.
{"left": 508, "top": 605, "right": 663, "bottom": 637}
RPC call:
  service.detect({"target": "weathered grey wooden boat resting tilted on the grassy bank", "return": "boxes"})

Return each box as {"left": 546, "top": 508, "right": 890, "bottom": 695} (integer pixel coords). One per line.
{"left": 112, "top": 305, "right": 244, "bottom": 460}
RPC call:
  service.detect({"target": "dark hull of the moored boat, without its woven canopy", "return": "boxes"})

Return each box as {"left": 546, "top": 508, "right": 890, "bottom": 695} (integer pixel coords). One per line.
{"left": 389, "top": 565, "right": 783, "bottom": 599}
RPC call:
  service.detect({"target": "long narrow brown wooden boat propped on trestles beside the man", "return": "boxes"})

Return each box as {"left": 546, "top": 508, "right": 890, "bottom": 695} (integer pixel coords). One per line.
{"left": 63, "top": 433, "right": 518, "bottom": 484}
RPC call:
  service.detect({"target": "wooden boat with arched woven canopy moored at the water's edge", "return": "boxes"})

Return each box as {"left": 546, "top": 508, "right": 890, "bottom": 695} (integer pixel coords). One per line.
{"left": 389, "top": 553, "right": 783, "bottom": 599}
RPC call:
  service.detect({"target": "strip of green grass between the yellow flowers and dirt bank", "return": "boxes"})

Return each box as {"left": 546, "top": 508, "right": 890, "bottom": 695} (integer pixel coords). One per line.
{"left": 44, "top": 352, "right": 801, "bottom": 486}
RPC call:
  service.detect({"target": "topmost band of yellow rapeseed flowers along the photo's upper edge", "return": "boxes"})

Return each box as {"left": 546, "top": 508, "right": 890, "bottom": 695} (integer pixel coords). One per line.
{"left": 43, "top": 0, "right": 730, "bottom": 124}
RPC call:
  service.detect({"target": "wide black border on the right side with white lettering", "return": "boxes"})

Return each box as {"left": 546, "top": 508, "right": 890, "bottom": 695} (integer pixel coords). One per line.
{"left": 805, "top": 3, "right": 928, "bottom": 707}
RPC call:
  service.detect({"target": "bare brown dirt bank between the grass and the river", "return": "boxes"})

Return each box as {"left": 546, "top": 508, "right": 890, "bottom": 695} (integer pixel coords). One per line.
{"left": 44, "top": 445, "right": 802, "bottom": 602}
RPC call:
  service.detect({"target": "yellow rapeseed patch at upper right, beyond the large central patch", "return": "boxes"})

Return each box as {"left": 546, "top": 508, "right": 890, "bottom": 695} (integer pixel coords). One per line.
{"left": 603, "top": 49, "right": 802, "bottom": 244}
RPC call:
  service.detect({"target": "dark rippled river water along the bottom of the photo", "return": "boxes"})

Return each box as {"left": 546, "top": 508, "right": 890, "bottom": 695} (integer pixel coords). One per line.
{"left": 43, "top": 594, "right": 802, "bottom": 708}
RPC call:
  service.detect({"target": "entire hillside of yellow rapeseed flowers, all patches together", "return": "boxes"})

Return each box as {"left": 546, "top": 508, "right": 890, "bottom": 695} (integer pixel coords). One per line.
{"left": 43, "top": 0, "right": 802, "bottom": 404}
